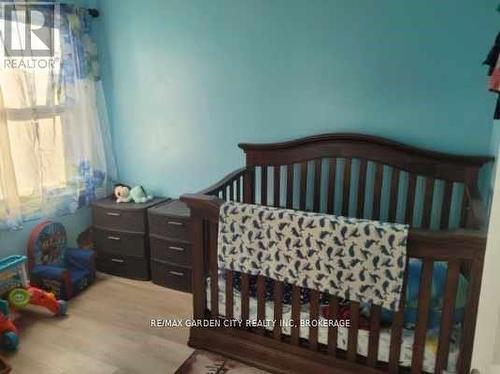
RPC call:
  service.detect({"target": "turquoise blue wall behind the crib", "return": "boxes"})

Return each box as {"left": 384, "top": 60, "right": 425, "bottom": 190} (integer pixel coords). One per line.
{"left": 98, "top": 0, "right": 500, "bottom": 196}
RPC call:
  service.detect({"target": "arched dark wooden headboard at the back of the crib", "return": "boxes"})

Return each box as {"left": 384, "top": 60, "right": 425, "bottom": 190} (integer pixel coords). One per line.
{"left": 238, "top": 133, "right": 493, "bottom": 229}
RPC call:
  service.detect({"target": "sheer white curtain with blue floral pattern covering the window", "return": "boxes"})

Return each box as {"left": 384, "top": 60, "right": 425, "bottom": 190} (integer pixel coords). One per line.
{"left": 0, "top": 5, "right": 116, "bottom": 228}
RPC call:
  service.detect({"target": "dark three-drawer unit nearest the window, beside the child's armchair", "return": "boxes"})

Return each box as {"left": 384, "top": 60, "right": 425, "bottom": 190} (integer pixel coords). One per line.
{"left": 92, "top": 198, "right": 171, "bottom": 280}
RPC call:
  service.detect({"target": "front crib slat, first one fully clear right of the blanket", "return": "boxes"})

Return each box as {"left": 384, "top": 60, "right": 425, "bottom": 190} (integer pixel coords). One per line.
{"left": 411, "top": 258, "right": 432, "bottom": 374}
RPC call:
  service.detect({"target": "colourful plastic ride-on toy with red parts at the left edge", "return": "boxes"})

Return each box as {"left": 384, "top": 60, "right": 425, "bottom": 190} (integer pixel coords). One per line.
{"left": 0, "top": 256, "right": 67, "bottom": 350}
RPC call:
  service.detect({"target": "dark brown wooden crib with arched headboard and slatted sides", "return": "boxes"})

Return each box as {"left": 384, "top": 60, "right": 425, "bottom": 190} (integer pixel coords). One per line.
{"left": 181, "top": 134, "right": 492, "bottom": 373}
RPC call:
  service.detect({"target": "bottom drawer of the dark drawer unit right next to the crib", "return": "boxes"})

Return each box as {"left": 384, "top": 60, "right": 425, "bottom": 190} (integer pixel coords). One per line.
{"left": 151, "top": 260, "right": 191, "bottom": 292}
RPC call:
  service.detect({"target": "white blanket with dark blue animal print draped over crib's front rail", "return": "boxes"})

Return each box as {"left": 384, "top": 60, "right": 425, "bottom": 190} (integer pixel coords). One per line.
{"left": 217, "top": 202, "right": 408, "bottom": 311}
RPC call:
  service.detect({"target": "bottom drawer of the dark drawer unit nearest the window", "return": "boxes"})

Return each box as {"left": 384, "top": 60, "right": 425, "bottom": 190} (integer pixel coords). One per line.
{"left": 96, "top": 252, "right": 149, "bottom": 280}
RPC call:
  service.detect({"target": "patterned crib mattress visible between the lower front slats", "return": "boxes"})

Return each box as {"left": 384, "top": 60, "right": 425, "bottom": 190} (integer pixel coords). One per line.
{"left": 207, "top": 275, "right": 459, "bottom": 373}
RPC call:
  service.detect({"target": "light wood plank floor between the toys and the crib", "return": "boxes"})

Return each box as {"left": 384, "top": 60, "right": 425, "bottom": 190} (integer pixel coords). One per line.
{"left": 2, "top": 274, "right": 193, "bottom": 374}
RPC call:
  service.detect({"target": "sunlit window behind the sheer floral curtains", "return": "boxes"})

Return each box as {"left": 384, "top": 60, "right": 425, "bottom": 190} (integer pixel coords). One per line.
{"left": 0, "top": 13, "right": 67, "bottom": 199}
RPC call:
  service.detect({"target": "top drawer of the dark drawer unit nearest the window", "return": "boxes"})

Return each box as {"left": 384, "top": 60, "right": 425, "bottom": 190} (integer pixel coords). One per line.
{"left": 92, "top": 206, "right": 146, "bottom": 233}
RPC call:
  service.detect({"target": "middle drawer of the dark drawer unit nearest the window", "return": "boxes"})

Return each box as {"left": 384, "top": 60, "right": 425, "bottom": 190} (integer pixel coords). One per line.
{"left": 94, "top": 228, "right": 146, "bottom": 257}
